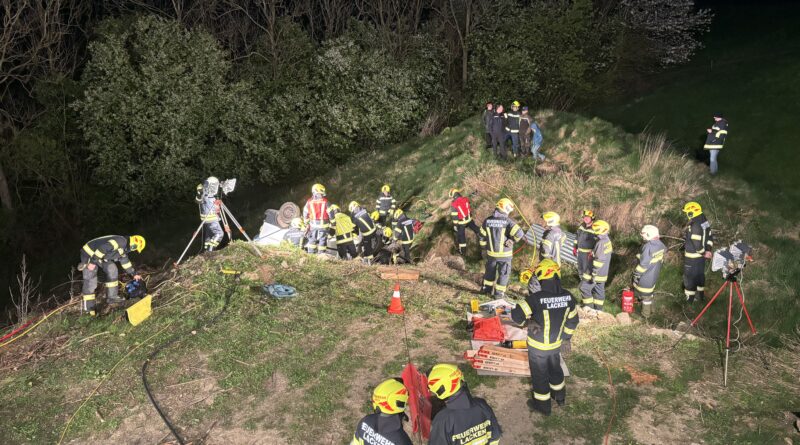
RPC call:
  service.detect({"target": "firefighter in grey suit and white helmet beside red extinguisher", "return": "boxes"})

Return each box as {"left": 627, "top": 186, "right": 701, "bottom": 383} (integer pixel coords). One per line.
{"left": 633, "top": 224, "right": 667, "bottom": 317}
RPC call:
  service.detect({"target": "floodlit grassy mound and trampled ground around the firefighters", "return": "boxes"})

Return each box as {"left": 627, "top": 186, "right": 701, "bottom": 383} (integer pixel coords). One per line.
{"left": 0, "top": 111, "right": 800, "bottom": 444}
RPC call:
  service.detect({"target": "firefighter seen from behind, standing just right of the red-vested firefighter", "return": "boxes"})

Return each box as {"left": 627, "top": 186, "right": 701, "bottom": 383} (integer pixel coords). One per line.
{"left": 480, "top": 198, "right": 527, "bottom": 298}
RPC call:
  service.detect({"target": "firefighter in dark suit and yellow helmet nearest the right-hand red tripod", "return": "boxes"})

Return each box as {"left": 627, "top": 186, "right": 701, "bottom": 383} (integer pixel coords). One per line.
{"left": 683, "top": 201, "right": 714, "bottom": 303}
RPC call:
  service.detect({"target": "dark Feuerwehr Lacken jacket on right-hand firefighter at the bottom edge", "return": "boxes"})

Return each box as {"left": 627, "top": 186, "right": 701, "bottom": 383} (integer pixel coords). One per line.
{"left": 428, "top": 382, "right": 503, "bottom": 445}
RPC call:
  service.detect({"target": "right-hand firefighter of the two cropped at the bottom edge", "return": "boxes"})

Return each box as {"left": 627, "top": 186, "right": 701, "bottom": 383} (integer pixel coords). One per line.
{"left": 428, "top": 363, "right": 503, "bottom": 445}
